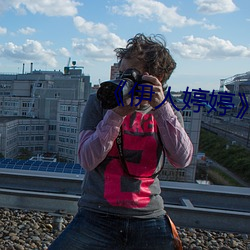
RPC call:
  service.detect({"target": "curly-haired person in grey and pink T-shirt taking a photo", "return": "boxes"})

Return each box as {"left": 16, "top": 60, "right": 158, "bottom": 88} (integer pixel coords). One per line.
{"left": 49, "top": 34, "right": 193, "bottom": 250}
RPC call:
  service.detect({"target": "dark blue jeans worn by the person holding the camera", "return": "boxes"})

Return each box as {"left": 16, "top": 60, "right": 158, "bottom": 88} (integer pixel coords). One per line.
{"left": 48, "top": 208, "right": 174, "bottom": 250}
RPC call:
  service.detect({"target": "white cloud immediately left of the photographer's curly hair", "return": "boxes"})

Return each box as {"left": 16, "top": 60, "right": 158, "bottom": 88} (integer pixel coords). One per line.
{"left": 72, "top": 16, "right": 126, "bottom": 61}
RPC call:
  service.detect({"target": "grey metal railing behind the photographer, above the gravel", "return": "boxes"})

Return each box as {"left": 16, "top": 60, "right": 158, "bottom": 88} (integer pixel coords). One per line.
{"left": 0, "top": 170, "right": 250, "bottom": 234}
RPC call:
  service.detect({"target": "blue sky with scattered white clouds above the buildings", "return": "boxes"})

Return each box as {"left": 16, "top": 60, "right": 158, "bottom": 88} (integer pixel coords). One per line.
{"left": 0, "top": 0, "right": 250, "bottom": 91}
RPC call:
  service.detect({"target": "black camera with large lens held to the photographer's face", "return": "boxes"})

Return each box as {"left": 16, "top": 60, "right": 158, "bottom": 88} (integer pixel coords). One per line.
{"left": 97, "top": 69, "right": 144, "bottom": 109}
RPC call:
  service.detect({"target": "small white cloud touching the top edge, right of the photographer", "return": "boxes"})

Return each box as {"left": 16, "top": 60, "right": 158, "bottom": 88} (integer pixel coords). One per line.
{"left": 194, "top": 0, "right": 238, "bottom": 15}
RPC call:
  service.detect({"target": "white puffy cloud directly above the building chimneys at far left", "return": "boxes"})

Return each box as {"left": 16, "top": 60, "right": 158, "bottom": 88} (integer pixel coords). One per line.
{"left": 0, "top": 40, "right": 57, "bottom": 67}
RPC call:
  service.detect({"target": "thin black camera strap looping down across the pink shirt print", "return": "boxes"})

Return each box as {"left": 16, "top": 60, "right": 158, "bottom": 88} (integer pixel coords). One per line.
{"left": 116, "top": 128, "right": 165, "bottom": 179}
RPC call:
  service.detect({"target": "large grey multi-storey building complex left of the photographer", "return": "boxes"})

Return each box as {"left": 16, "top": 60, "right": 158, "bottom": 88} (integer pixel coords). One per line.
{"left": 0, "top": 64, "right": 91, "bottom": 162}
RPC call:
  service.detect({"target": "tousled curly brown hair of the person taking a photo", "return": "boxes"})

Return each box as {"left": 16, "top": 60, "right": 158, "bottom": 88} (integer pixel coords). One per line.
{"left": 115, "top": 33, "right": 176, "bottom": 83}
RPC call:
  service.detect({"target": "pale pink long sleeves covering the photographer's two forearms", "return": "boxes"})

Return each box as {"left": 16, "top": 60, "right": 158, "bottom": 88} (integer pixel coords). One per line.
{"left": 78, "top": 102, "right": 193, "bottom": 171}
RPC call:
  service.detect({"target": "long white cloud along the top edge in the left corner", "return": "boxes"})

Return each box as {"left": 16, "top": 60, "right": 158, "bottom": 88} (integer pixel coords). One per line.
{"left": 0, "top": 0, "right": 82, "bottom": 16}
